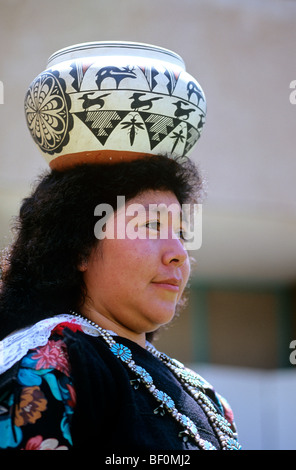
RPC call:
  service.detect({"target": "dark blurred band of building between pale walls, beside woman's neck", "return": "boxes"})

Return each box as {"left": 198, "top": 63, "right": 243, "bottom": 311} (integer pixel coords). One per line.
{"left": 155, "top": 283, "right": 296, "bottom": 370}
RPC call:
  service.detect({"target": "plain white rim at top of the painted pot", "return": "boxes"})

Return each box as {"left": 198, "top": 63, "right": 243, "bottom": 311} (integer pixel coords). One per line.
{"left": 47, "top": 41, "right": 185, "bottom": 69}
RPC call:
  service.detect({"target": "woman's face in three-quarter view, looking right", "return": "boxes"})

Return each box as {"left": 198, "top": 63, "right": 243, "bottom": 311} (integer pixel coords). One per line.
{"left": 81, "top": 191, "right": 190, "bottom": 342}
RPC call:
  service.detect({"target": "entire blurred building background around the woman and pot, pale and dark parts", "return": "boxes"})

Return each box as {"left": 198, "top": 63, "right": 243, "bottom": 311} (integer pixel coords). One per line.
{"left": 0, "top": 0, "right": 296, "bottom": 449}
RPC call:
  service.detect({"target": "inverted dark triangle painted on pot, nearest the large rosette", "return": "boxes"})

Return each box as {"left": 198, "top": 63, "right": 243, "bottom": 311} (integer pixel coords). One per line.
{"left": 75, "top": 111, "right": 129, "bottom": 145}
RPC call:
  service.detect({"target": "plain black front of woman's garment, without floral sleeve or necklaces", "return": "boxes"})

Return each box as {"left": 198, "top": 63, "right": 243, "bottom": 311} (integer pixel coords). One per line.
{"left": 66, "top": 331, "right": 220, "bottom": 451}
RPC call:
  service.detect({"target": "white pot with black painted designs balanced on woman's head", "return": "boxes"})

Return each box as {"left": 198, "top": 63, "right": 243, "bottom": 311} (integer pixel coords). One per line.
{"left": 25, "top": 42, "right": 206, "bottom": 169}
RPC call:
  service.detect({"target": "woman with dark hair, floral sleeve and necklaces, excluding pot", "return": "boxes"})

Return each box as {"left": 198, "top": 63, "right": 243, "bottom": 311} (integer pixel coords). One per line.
{"left": 0, "top": 156, "right": 239, "bottom": 452}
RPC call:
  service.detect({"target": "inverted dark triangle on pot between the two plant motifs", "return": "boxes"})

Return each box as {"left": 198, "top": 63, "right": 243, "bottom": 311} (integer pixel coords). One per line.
{"left": 139, "top": 111, "right": 181, "bottom": 150}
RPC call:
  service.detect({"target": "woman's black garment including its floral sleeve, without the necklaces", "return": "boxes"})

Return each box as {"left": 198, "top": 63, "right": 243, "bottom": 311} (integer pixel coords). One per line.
{"left": 0, "top": 325, "right": 238, "bottom": 454}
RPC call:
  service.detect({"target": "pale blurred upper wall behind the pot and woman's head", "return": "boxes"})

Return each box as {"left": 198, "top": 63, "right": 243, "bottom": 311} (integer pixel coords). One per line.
{"left": 0, "top": 0, "right": 296, "bottom": 282}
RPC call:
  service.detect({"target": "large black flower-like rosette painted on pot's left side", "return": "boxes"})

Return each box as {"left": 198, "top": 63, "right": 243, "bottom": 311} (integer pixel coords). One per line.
{"left": 25, "top": 71, "right": 73, "bottom": 155}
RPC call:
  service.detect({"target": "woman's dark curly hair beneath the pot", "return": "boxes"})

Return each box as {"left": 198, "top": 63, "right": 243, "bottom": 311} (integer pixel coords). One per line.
{"left": 0, "top": 156, "right": 202, "bottom": 339}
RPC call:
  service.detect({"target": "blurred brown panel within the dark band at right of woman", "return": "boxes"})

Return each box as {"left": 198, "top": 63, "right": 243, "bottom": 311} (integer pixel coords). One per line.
{"left": 209, "top": 290, "right": 278, "bottom": 368}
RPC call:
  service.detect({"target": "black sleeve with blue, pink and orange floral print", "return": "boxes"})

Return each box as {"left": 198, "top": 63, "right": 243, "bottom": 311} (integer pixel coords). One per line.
{"left": 0, "top": 324, "right": 76, "bottom": 450}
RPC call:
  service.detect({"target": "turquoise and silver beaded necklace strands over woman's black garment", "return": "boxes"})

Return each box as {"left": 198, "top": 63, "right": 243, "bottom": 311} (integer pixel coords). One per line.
{"left": 71, "top": 311, "right": 241, "bottom": 450}
